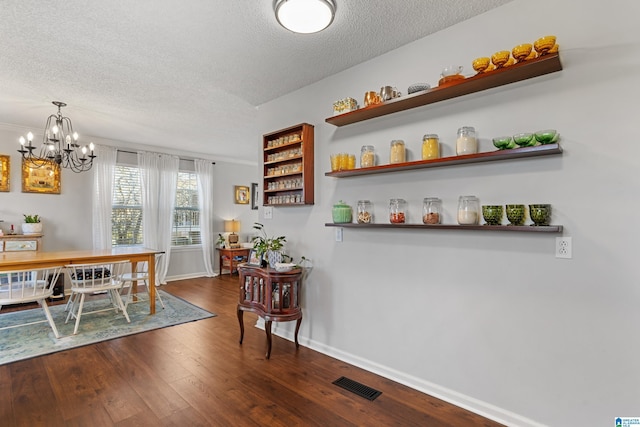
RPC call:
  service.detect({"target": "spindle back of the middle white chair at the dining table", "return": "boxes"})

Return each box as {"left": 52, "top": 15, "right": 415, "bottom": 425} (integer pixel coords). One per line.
{"left": 65, "top": 261, "right": 129, "bottom": 291}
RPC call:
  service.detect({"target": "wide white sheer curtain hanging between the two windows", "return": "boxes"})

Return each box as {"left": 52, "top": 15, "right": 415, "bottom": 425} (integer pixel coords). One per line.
{"left": 138, "top": 152, "right": 180, "bottom": 284}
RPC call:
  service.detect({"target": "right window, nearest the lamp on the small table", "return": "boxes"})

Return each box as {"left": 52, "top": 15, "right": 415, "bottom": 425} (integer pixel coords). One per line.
{"left": 171, "top": 172, "right": 202, "bottom": 246}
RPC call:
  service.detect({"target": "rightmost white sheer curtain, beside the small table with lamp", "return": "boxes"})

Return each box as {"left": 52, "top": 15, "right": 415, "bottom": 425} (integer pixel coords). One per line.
{"left": 194, "top": 159, "right": 216, "bottom": 277}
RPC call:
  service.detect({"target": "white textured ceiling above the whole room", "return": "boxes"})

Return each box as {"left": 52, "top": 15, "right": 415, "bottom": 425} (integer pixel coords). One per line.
{"left": 0, "top": 0, "right": 510, "bottom": 162}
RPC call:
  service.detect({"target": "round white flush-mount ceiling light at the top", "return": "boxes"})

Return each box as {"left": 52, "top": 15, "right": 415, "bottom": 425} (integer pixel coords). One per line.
{"left": 275, "top": 0, "right": 336, "bottom": 34}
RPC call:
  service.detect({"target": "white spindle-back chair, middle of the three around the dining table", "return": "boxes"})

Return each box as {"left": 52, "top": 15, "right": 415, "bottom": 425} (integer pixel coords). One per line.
{"left": 65, "top": 261, "right": 131, "bottom": 335}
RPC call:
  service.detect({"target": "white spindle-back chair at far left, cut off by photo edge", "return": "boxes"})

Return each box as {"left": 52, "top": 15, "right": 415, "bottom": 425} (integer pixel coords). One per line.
{"left": 0, "top": 267, "right": 62, "bottom": 338}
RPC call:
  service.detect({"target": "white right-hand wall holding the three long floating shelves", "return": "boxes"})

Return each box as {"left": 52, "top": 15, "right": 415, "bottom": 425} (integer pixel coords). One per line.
{"left": 256, "top": 0, "right": 640, "bottom": 426}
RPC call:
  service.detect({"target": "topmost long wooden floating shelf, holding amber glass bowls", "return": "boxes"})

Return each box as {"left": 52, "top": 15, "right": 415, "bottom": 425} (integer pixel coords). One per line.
{"left": 325, "top": 53, "right": 562, "bottom": 126}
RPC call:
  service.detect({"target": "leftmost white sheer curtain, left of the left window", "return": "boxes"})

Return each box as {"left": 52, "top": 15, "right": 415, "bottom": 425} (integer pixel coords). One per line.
{"left": 92, "top": 145, "right": 118, "bottom": 249}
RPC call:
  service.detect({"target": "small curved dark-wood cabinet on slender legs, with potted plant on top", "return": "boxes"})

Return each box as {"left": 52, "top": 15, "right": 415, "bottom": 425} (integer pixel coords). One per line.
{"left": 238, "top": 264, "right": 302, "bottom": 359}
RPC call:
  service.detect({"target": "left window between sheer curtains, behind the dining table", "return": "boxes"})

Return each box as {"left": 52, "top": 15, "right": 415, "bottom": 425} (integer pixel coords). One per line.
{"left": 111, "top": 165, "right": 143, "bottom": 246}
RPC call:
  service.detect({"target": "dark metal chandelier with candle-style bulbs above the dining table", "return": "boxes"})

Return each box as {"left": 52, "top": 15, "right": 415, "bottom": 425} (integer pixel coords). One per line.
{"left": 18, "top": 101, "right": 96, "bottom": 172}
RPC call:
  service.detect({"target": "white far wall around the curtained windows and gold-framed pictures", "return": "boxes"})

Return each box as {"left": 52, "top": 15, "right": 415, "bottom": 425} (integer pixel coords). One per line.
{"left": 0, "top": 123, "right": 259, "bottom": 280}
